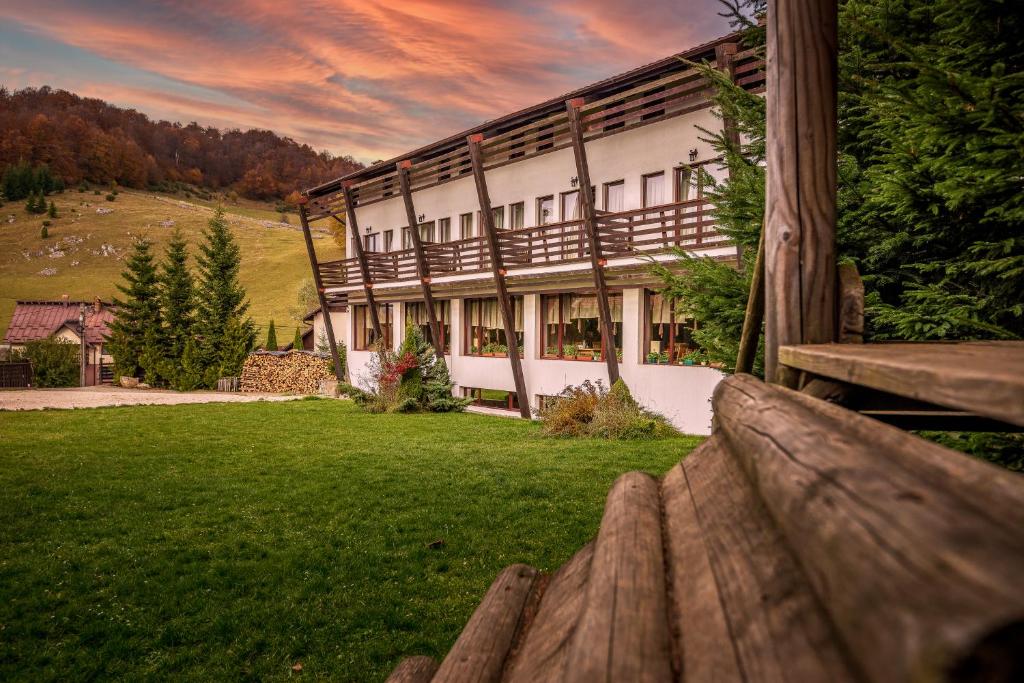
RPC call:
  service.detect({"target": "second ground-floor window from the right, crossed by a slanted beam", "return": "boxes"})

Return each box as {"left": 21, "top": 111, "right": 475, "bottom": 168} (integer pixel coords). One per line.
{"left": 541, "top": 293, "right": 623, "bottom": 360}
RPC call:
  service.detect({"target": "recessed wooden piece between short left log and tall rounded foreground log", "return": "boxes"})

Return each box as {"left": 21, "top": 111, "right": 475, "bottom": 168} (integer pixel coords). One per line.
{"left": 505, "top": 543, "right": 594, "bottom": 683}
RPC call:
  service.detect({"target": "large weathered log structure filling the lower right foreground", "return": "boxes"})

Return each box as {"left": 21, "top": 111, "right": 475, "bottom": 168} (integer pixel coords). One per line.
{"left": 389, "top": 375, "right": 1024, "bottom": 682}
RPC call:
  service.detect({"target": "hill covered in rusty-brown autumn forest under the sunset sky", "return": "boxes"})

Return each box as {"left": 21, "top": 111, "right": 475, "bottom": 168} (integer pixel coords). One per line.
{"left": 0, "top": 86, "right": 362, "bottom": 200}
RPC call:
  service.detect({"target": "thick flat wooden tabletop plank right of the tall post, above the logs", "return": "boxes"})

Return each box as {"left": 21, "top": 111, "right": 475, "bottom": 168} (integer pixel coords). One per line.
{"left": 779, "top": 342, "right": 1024, "bottom": 426}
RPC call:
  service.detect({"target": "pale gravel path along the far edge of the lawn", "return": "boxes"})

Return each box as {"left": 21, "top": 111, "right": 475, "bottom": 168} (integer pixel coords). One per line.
{"left": 0, "top": 386, "right": 302, "bottom": 411}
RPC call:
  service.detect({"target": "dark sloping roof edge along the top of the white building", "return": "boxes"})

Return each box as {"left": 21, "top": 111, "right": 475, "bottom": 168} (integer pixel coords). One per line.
{"left": 305, "top": 32, "right": 741, "bottom": 197}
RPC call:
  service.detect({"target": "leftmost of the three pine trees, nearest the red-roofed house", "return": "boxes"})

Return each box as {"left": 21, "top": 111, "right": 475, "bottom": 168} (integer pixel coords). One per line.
{"left": 108, "top": 240, "right": 161, "bottom": 377}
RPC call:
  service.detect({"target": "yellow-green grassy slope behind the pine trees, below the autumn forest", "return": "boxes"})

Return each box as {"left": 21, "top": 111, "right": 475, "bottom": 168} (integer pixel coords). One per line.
{"left": 0, "top": 189, "right": 342, "bottom": 344}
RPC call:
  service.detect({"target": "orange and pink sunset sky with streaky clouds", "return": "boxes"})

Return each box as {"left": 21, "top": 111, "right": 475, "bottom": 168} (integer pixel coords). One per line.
{"left": 0, "top": 0, "right": 728, "bottom": 162}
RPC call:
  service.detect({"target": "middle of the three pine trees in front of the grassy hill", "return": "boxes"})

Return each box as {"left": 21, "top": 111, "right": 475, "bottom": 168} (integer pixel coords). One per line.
{"left": 160, "top": 229, "right": 196, "bottom": 365}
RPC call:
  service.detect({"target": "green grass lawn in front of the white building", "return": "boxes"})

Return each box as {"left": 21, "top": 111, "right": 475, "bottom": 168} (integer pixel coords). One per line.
{"left": 0, "top": 400, "right": 700, "bottom": 681}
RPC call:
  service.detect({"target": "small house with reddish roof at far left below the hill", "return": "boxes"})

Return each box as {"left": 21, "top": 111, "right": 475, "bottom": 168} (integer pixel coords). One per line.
{"left": 3, "top": 296, "right": 114, "bottom": 385}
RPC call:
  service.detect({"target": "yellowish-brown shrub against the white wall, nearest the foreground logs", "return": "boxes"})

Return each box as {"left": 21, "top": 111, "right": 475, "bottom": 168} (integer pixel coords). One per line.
{"left": 540, "top": 379, "right": 678, "bottom": 439}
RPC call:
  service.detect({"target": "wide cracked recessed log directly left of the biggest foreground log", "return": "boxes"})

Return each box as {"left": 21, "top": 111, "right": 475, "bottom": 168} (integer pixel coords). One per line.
{"left": 666, "top": 436, "right": 857, "bottom": 682}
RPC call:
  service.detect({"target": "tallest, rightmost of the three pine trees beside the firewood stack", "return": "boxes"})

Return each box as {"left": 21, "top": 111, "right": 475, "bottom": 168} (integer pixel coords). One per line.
{"left": 197, "top": 208, "right": 256, "bottom": 386}
